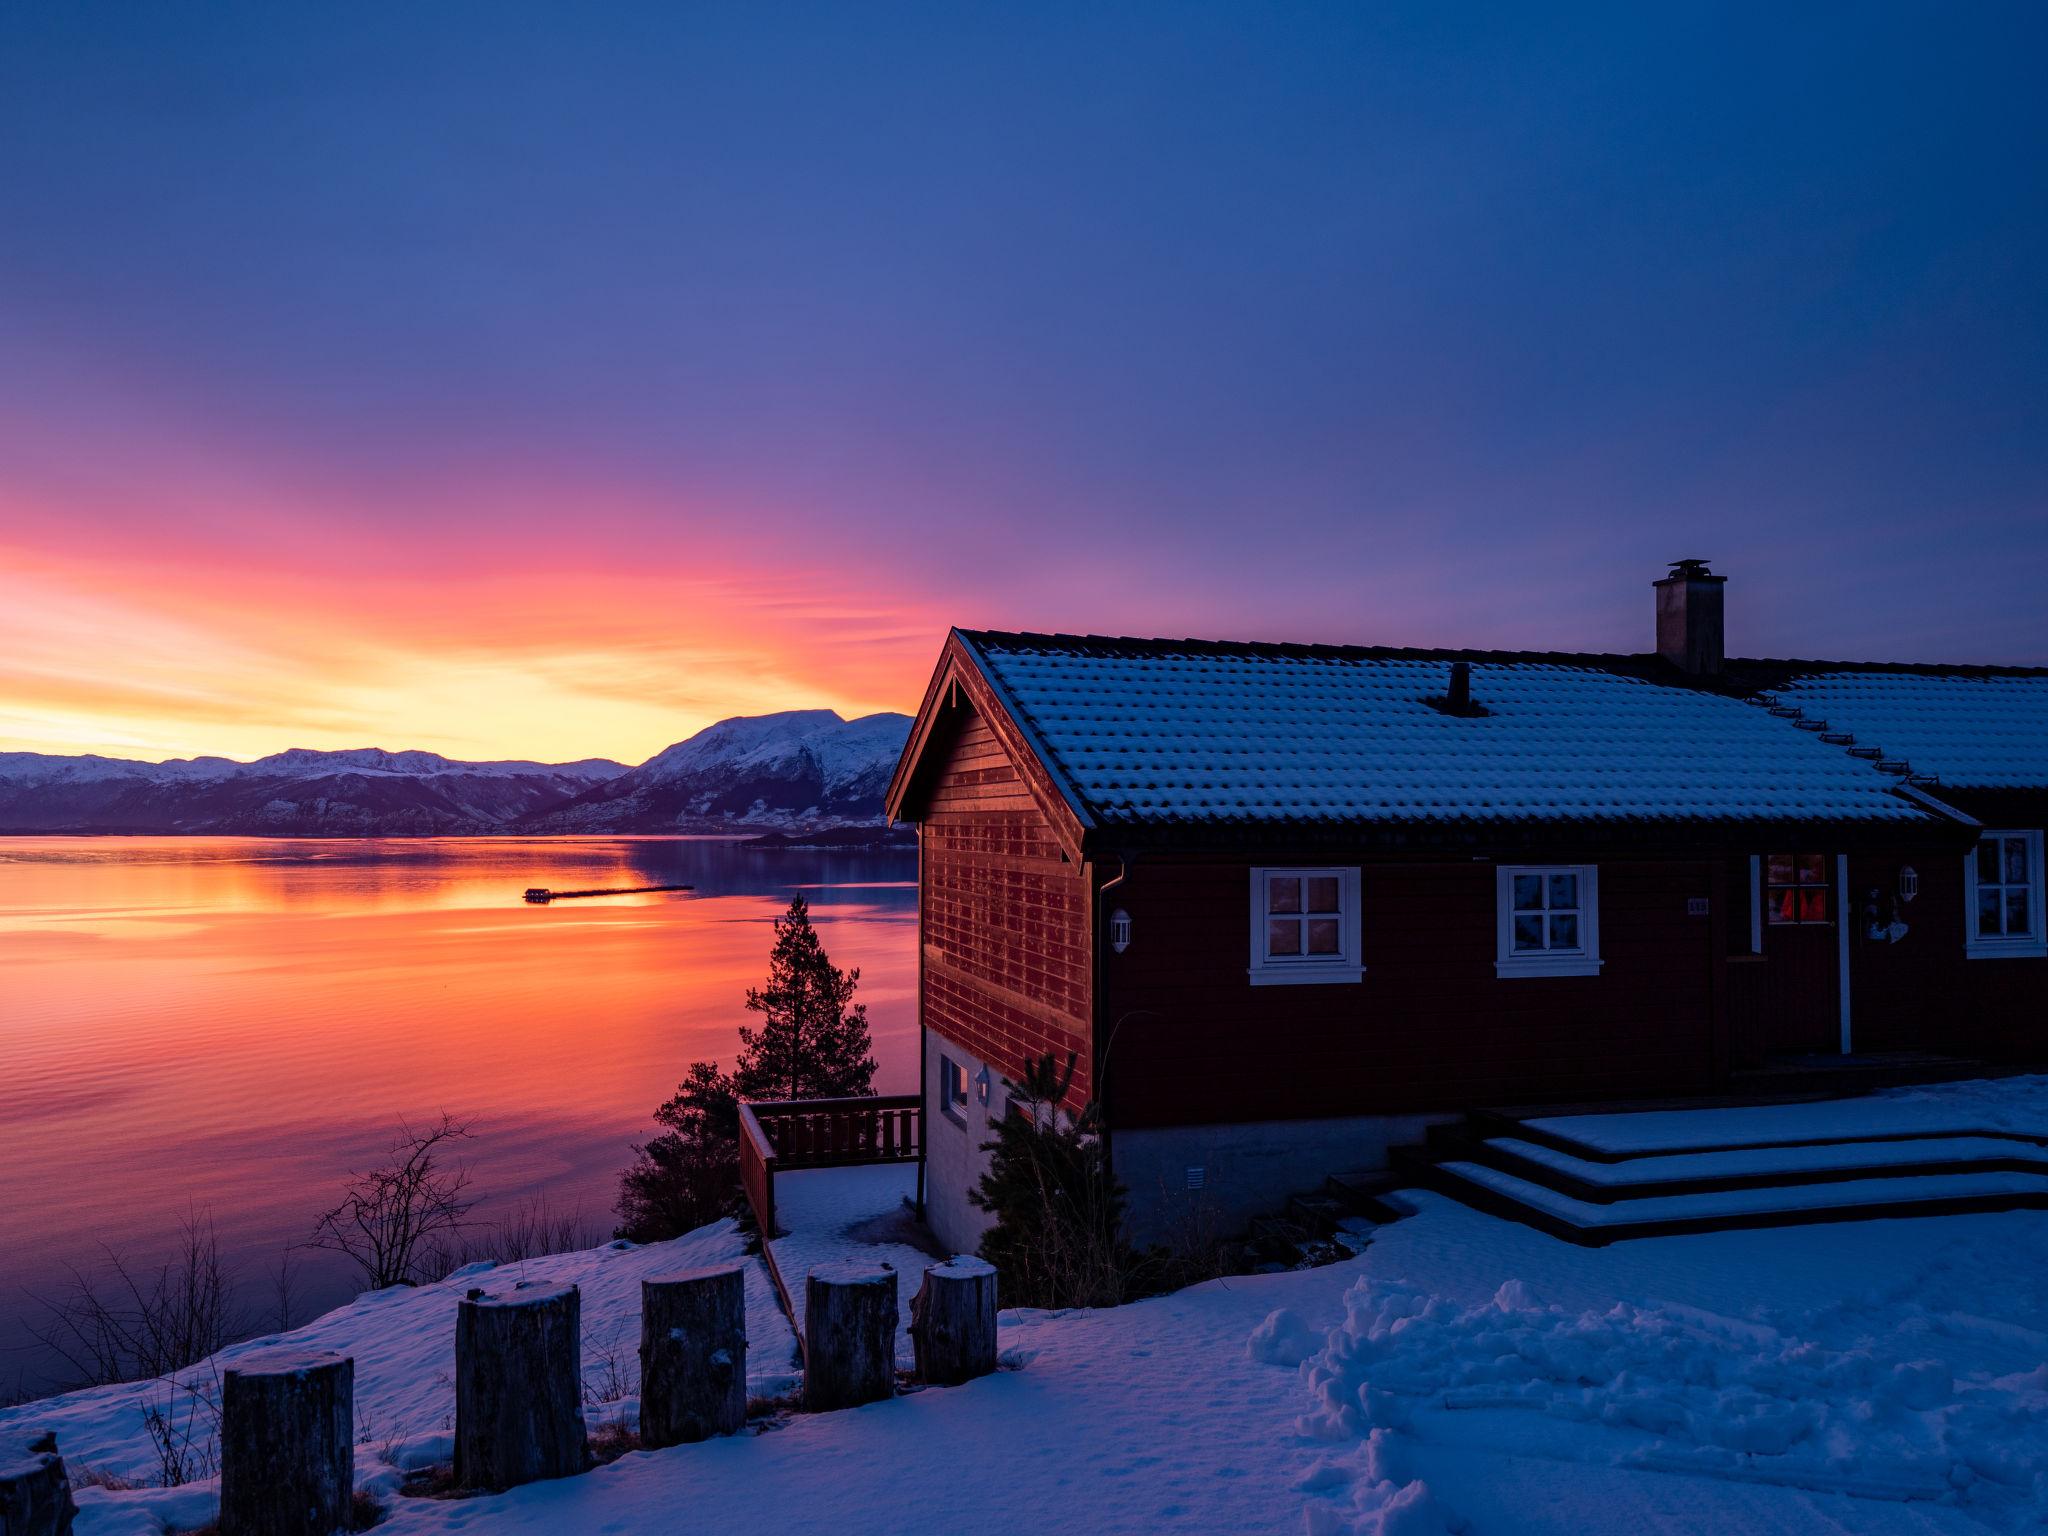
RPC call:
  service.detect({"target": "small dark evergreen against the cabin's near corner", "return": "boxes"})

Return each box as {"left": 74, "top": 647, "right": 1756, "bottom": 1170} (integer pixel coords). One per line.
{"left": 967, "top": 1055, "right": 1133, "bottom": 1307}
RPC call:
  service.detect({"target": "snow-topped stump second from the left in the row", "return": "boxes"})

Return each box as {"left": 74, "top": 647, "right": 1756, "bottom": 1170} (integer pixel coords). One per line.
{"left": 221, "top": 1350, "right": 356, "bottom": 1536}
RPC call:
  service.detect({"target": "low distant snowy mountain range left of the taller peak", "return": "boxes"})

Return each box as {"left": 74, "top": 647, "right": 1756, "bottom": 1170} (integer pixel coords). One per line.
{"left": 0, "top": 748, "right": 627, "bottom": 838}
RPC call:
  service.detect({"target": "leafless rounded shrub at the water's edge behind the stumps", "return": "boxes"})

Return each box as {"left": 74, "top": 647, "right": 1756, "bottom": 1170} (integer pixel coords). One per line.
{"left": 307, "top": 1114, "right": 475, "bottom": 1290}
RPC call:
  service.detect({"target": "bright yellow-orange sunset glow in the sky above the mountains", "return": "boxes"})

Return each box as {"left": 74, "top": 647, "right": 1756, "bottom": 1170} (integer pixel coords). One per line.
{"left": 0, "top": 532, "right": 946, "bottom": 764}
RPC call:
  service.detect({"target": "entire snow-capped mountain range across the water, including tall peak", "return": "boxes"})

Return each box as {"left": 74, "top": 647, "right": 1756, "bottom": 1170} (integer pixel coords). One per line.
{"left": 0, "top": 709, "right": 909, "bottom": 838}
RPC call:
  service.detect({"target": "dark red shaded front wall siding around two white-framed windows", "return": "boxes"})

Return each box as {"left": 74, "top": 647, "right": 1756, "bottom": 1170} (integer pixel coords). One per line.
{"left": 1104, "top": 860, "right": 1724, "bottom": 1126}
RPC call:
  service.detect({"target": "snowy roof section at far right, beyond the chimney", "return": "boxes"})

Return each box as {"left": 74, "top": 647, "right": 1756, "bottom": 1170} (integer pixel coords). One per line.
{"left": 1769, "top": 668, "right": 2048, "bottom": 788}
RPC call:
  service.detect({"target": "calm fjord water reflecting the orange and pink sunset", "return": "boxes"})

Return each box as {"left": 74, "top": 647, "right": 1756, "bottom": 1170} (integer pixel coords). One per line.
{"left": 0, "top": 838, "right": 918, "bottom": 1399}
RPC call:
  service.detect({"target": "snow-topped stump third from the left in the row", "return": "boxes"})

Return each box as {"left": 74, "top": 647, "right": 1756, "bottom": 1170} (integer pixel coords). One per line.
{"left": 455, "top": 1280, "right": 590, "bottom": 1489}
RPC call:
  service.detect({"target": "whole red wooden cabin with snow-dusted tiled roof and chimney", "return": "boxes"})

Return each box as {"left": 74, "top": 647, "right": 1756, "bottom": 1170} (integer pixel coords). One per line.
{"left": 889, "top": 561, "right": 2048, "bottom": 1251}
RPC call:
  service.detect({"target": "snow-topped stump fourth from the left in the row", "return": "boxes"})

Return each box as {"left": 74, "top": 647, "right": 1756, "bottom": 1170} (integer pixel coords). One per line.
{"left": 641, "top": 1264, "right": 748, "bottom": 1450}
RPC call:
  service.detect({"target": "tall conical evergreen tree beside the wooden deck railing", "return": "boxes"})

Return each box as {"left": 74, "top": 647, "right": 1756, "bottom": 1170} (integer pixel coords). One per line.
{"left": 733, "top": 893, "right": 874, "bottom": 1100}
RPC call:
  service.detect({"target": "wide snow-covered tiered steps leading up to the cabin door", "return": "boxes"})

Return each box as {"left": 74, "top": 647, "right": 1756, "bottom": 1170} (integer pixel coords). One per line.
{"left": 1403, "top": 1096, "right": 2048, "bottom": 1243}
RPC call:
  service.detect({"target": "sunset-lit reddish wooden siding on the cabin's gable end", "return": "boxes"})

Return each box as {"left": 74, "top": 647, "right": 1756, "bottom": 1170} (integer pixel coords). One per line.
{"left": 920, "top": 715, "right": 1090, "bottom": 1108}
